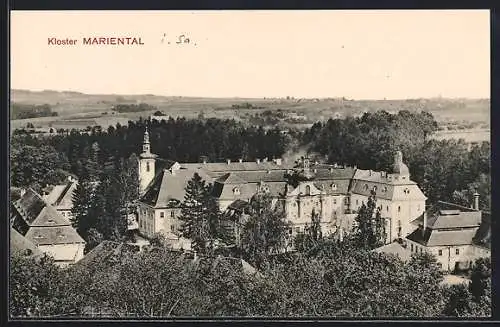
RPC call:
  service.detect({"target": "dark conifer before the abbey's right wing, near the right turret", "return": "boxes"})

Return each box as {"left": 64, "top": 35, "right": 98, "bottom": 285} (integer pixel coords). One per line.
{"left": 353, "top": 195, "right": 386, "bottom": 249}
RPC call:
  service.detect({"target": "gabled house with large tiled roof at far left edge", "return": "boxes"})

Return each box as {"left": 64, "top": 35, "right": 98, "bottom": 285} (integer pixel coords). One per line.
{"left": 10, "top": 189, "right": 85, "bottom": 266}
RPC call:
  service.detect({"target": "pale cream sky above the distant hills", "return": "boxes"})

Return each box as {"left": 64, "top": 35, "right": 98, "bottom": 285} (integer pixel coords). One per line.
{"left": 10, "top": 10, "right": 490, "bottom": 99}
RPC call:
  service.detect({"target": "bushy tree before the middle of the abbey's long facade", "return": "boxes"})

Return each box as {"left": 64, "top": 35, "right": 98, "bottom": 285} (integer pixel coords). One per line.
{"left": 241, "top": 194, "right": 289, "bottom": 266}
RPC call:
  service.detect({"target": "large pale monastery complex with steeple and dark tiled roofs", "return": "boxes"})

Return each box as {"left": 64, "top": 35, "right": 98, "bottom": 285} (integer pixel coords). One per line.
{"left": 138, "top": 130, "right": 426, "bottom": 246}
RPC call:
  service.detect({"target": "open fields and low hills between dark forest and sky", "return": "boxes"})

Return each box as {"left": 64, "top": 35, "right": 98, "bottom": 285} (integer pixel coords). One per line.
{"left": 11, "top": 90, "right": 490, "bottom": 139}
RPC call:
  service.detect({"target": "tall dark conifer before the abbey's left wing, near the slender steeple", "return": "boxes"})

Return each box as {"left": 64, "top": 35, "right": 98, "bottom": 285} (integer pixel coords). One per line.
{"left": 179, "top": 173, "right": 222, "bottom": 254}
